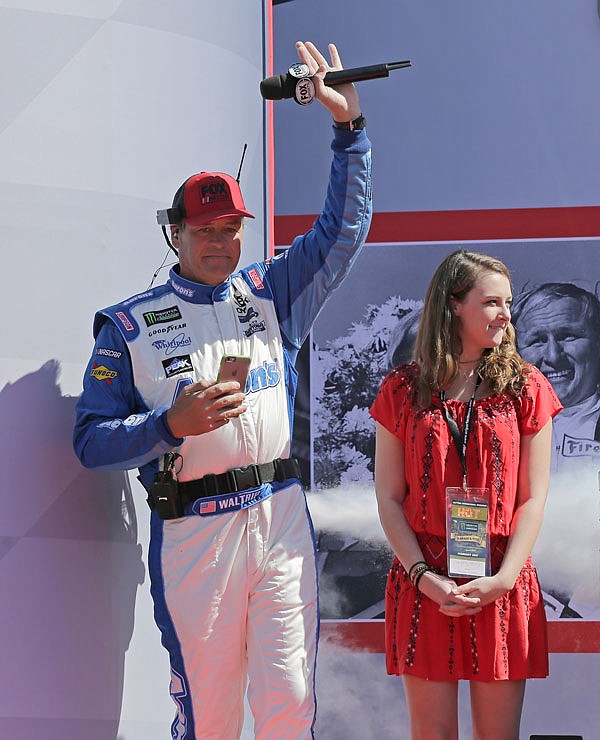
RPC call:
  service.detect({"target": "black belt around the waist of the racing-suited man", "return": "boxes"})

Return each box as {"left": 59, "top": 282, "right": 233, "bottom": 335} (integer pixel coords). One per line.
{"left": 178, "top": 457, "right": 300, "bottom": 506}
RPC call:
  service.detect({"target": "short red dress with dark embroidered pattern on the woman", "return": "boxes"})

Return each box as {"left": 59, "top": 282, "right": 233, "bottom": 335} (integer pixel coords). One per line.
{"left": 370, "top": 363, "right": 562, "bottom": 681}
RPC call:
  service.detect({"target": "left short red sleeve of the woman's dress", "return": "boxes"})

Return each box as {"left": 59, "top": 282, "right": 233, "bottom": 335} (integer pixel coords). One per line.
{"left": 369, "top": 363, "right": 418, "bottom": 440}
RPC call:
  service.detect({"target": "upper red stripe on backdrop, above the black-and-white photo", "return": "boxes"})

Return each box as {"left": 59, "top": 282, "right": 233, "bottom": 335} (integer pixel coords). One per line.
{"left": 275, "top": 206, "right": 600, "bottom": 247}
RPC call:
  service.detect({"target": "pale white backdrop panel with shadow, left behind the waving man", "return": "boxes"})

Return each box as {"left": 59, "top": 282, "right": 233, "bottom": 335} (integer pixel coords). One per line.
{"left": 0, "top": 0, "right": 270, "bottom": 740}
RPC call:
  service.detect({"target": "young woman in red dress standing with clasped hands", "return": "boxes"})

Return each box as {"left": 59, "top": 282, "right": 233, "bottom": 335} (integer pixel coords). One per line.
{"left": 371, "top": 250, "right": 562, "bottom": 740}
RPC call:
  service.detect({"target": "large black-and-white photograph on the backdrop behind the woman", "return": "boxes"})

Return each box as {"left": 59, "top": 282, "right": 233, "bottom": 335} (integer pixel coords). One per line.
{"left": 310, "top": 239, "right": 600, "bottom": 620}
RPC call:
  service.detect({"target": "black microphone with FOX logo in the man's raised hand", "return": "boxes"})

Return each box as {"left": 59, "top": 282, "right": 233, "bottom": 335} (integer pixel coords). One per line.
{"left": 260, "top": 60, "right": 411, "bottom": 105}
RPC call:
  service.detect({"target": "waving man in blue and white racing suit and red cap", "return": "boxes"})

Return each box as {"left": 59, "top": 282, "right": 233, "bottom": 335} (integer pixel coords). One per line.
{"left": 74, "top": 43, "right": 371, "bottom": 740}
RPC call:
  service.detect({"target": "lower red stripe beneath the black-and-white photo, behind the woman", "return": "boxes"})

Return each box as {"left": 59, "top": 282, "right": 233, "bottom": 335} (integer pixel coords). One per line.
{"left": 320, "top": 619, "right": 600, "bottom": 653}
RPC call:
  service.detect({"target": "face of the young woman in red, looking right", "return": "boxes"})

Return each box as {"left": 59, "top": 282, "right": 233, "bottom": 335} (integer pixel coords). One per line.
{"left": 451, "top": 271, "right": 512, "bottom": 359}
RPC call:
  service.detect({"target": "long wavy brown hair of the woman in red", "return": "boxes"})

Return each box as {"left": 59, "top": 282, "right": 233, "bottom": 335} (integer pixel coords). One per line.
{"left": 414, "top": 249, "right": 528, "bottom": 409}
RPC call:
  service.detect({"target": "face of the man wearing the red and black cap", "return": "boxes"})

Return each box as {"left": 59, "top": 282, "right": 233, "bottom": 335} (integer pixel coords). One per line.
{"left": 171, "top": 216, "right": 243, "bottom": 285}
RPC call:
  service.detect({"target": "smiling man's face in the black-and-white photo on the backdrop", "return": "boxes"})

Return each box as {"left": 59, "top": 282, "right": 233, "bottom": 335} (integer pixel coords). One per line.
{"left": 517, "top": 297, "right": 600, "bottom": 406}
